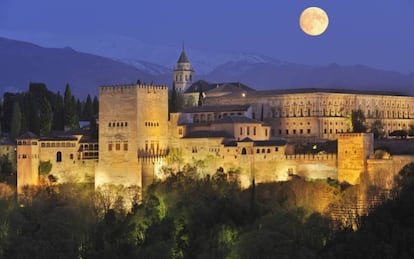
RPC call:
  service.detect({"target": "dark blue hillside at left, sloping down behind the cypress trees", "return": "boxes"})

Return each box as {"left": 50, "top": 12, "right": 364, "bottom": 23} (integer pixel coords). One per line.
{"left": 0, "top": 38, "right": 170, "bottom": 98}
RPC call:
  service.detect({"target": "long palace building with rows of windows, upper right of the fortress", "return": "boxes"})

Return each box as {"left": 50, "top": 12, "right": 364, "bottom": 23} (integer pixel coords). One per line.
{"left": 204, "top": 88, "right": 414, "bottom": 142}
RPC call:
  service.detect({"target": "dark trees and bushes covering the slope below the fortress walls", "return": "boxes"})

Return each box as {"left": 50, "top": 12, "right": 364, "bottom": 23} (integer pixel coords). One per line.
{"left": 0, "top": 165, "right": 414, "bottom": 258}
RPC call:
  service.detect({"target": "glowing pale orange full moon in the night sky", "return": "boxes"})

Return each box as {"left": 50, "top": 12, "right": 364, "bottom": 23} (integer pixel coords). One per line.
{"left": 299, "top": 7, "right": 329, "bottom": 36}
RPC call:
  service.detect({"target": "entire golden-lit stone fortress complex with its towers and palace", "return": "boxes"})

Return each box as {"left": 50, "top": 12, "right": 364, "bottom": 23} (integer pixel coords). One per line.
{"left": 16, "top": 50, "right": 414, "bottom": 197}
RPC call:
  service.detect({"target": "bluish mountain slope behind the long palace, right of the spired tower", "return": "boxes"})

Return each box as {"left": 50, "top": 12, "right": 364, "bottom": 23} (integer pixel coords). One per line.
{"left": 206, "top": 60, "right": 414, "bottom": 95}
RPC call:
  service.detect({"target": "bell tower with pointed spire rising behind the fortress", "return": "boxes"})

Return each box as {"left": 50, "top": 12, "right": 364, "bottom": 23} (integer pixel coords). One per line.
{"left": 174, "top": 47, "right": 194, "bottom": 93}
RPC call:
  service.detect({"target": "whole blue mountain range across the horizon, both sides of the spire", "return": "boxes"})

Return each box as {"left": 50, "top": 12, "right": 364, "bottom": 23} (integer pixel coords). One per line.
{"left": 0, "top": 37, "right": 414, "bottom": 97}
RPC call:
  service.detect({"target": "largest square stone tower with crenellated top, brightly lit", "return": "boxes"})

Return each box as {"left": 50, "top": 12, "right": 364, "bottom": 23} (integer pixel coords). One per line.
{"left": 95, "top": 84, "right": 168, "bottom": 192}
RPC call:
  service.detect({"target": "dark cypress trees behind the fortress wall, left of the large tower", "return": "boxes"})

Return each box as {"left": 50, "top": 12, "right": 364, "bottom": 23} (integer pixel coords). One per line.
{"left": 0, "top": 83, "right": 99, "bottom": 137}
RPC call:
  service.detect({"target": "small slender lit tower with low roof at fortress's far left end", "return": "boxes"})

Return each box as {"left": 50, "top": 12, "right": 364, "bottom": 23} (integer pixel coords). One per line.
{"left": 17, "top": 132, "right": 39, "bottom": 193}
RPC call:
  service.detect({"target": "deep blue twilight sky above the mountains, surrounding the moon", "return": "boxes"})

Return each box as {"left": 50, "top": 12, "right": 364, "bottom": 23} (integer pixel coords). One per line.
{"left": 0, "top": 0, "right": 414, "bottom": 73}
